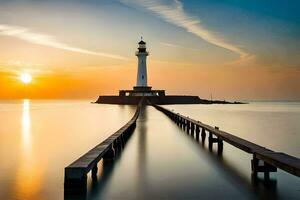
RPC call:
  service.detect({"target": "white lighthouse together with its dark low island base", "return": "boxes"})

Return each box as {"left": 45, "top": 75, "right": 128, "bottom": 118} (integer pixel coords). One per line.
{"left": 95, "top": 40, "right": 238, "bottom": 105}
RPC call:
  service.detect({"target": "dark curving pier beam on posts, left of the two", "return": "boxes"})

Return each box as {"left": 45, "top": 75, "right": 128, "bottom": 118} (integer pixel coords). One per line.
{"left": 64, "top": 99, "right": 144, "bottom": 192}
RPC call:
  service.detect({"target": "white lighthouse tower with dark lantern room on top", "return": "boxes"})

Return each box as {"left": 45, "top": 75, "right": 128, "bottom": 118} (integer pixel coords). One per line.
{"left": 135, "top": 40, "right": 149, "bottom": 88}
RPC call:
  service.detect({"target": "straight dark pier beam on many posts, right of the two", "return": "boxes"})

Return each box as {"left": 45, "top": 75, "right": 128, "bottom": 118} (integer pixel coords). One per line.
{"left": 153, "top": 105, "right": 300, "bottom": 178}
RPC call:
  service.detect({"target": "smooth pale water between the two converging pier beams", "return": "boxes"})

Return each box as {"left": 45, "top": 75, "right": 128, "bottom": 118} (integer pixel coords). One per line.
{"left": 76, "top": 106, "right": 299, "bottom": 199}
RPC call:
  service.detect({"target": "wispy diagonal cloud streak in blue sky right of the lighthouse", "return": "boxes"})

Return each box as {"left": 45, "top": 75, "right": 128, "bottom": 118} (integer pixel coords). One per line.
{"left": 121, "top": 0, "right": 250, "bottom": 59}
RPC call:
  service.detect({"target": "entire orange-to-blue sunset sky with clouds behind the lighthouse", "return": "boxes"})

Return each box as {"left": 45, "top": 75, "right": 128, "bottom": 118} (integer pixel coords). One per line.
{"left": 0, "top": 0, "right": 300, "bottom": 100}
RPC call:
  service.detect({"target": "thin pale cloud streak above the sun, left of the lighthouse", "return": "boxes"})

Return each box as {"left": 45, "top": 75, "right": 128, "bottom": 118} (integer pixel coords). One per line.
{"left": 0, "top": 24, "right": 126, "bottom": 60}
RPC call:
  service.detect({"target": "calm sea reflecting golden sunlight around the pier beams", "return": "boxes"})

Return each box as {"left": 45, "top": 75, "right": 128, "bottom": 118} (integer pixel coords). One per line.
{"left": 0, "top": 100, "right": 300, "bottom": 200}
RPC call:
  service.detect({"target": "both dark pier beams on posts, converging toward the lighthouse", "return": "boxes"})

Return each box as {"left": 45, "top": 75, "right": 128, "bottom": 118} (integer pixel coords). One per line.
{"left": 64, "top": 102, "right": 300, "bottom": 193}
